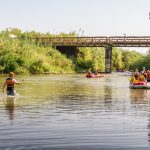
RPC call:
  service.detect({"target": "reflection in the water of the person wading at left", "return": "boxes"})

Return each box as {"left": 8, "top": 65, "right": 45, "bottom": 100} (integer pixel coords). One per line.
{"left": 3, "top": 97, "right": 16, "bottom": 120}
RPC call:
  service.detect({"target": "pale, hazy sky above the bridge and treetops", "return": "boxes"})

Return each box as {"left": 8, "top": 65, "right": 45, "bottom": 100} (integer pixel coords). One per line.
{"left": 0, "top": 0, "right": 150, "bottom": 51}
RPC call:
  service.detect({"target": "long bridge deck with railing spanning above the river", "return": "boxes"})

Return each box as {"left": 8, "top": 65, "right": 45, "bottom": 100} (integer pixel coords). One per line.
{"left": 36, "top": 36, "right": 150, "bottom": 47}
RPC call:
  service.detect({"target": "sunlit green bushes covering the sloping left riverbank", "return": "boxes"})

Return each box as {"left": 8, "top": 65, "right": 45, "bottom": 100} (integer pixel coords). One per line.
{"left": 0, "top": 28, "right": 74, "bottom": 73}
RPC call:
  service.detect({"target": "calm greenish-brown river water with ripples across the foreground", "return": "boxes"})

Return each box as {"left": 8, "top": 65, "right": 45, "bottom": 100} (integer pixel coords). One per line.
{"left": 0, "top": 73, "right": 150, "bottom": 150}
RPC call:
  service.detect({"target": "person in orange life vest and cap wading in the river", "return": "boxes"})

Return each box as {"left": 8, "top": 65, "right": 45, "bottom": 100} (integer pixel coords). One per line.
{"left": 3, "top": 72, "right": 21, "bottom": 96}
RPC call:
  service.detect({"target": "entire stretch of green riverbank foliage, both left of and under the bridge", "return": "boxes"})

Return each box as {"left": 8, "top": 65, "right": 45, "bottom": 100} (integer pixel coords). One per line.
{"left": 0, "top": 28, "right": 150, "bottom": 74}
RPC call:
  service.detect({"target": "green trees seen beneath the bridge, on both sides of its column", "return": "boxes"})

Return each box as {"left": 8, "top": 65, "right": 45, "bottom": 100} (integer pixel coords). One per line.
{"left": 76, "top": 48, "right": 144, "bottom": 71}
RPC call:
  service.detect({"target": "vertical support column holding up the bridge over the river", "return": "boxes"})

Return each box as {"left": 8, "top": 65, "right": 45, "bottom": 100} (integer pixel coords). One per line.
{"left": 105, "top": 46, "right": 112, "bottom": 73}
